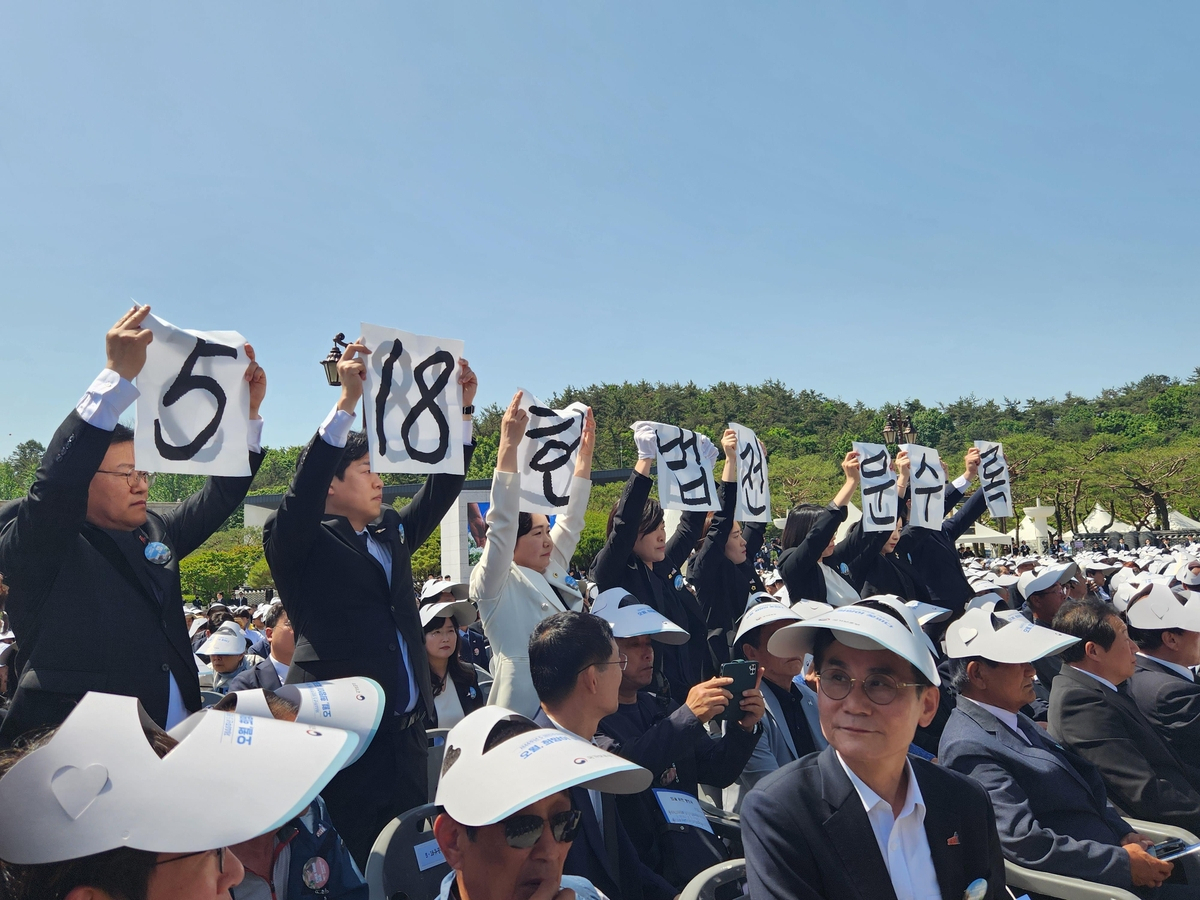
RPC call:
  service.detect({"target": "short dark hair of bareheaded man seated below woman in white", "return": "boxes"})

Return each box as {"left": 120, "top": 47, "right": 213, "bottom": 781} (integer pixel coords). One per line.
{"left": 529, "top": 612, "right": 612, "bottom": 706}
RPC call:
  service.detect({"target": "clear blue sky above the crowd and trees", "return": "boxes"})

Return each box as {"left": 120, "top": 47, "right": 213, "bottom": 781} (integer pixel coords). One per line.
{"left": 0, "top": 0, "right": 1200, "bottom": 454}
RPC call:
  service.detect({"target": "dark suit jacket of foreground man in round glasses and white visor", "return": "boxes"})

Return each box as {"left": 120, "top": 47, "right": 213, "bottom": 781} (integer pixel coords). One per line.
{"left": 742, "top": 746, "right": 1006, "bottom": 900}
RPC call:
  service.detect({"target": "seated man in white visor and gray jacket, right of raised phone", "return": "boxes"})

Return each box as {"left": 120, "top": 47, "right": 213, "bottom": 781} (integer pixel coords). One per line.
{"left": 722, "top": 598, "right": 833, "bottom": 812}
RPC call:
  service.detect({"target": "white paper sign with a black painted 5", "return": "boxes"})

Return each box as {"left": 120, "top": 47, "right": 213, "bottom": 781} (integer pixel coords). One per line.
{"left": 133, "top": 316, "right": 250, "bottom": 476}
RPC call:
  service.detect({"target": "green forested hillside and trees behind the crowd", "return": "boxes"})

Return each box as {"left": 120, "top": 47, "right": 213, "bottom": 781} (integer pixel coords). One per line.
{"left": 0, "top": 367, "right": 1200, "bottom": 596}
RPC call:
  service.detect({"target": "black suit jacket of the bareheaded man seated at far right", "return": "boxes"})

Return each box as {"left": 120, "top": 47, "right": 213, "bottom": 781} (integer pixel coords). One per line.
{"left": 1049, "top": 665, "right": 1200, "bottom": 833}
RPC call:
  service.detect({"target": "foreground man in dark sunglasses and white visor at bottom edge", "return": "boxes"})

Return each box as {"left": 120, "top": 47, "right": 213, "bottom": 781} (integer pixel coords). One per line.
{"left": 433, "top": 706, "right": 650, "bottom": 900}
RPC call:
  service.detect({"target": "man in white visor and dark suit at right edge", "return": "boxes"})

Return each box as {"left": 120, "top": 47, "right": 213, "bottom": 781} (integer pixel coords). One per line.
{"left": 1126, "top": 584, "right": 1200, "bottom": 770}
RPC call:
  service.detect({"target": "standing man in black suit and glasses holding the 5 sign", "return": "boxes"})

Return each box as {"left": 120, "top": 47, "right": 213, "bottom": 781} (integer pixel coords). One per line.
{"left": 0, "top": 306, "right": 266, "bottom": 743}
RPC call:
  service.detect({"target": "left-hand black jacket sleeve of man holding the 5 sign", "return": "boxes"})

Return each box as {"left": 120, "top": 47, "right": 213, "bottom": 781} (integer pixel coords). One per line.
{"left": 0, "top": 412, "right": 113, "bottom": 616}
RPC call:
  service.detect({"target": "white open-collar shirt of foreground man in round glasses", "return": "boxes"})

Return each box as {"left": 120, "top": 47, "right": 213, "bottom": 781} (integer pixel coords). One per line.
{"left": 836, "top": 754, "right": 942, "bottom": 900}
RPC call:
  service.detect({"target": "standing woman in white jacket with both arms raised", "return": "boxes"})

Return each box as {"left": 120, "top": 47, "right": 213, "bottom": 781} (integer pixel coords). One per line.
{"left": 470, "top": 391, "right": 595, "bottom": 718}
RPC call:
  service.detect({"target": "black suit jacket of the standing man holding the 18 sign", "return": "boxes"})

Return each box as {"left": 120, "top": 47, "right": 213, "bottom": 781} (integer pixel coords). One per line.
{"left": 263, "top": 434, "right": 474, "bottom": 722}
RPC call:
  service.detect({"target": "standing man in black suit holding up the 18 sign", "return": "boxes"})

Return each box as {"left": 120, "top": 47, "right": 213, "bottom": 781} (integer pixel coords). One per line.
{"left": 263, "top": 343, "right": 478, "bottom": 866}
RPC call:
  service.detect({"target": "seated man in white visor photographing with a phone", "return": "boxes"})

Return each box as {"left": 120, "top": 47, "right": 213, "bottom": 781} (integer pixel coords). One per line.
{"left": 592, "top": 588, "right": 766, "bottom": 889}
